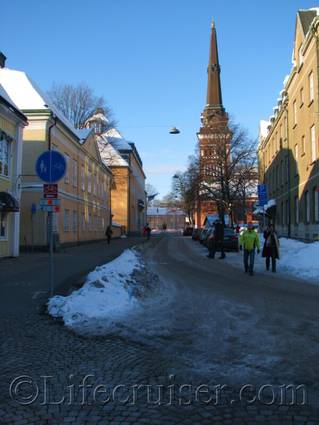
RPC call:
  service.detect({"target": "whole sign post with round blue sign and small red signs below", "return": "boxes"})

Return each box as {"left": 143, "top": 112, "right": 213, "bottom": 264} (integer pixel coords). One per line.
{"left": 35, "top": 150, "right": 66, "bottom": 296}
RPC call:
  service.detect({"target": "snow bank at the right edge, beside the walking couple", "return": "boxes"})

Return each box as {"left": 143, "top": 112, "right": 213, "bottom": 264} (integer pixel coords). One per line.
{"left": 278, "top": 238, "right": 319, "bottom": 282}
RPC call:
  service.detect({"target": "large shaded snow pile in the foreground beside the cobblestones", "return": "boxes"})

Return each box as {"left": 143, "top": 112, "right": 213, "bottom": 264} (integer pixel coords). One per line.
{"left": 48, "top": 250, "right": 143, "bottom": 327}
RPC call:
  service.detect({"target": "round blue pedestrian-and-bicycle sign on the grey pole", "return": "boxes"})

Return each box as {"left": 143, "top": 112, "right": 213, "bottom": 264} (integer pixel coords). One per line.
{"left": 35, "top": 151, "right": 66, "bottom": 183}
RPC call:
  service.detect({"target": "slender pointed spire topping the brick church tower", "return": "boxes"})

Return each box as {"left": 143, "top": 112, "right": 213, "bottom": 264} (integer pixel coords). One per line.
{"left": 207, "top": 21, "right": 224, "bottom": 111}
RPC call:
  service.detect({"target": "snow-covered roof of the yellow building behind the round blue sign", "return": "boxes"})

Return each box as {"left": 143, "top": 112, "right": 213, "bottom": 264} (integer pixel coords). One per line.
{"left": 0, "top": 68, "right": 92, "bottom": 139}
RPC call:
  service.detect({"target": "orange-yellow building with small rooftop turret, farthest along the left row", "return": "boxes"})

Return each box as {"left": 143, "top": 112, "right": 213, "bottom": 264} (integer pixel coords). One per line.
{"left": 87, "top": 109, "right": 146, "bottom": 235}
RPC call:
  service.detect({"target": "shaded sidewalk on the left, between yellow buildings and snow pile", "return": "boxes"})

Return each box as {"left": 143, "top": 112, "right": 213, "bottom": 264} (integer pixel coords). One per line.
{"left": 0, "top": 237, "right": 145, "bottom": 316}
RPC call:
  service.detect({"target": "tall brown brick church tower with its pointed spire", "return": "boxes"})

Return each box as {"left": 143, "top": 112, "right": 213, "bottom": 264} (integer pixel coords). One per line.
{"left": 196, "top": 21, "right": 231, "bottom": 227}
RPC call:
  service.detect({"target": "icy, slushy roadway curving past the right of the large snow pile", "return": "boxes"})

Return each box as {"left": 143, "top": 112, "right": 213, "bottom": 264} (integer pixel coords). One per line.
{"left": 144, "top": 237, "right": 319, "bottom": 403}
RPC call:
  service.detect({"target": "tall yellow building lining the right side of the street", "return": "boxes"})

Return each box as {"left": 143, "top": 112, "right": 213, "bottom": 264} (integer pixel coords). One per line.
{"left": 258, "top": 9, "right": 319, "bottom": 240}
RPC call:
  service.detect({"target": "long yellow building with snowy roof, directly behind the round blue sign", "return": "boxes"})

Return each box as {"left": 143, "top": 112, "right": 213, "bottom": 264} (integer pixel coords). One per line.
{"left": 0, "top": 68, "right": 112, "bottom": 248}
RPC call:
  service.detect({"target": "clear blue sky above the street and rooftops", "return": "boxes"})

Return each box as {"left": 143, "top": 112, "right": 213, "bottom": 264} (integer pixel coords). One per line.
{"left": 0, "top": 0, "right": 318, "bottom": 195}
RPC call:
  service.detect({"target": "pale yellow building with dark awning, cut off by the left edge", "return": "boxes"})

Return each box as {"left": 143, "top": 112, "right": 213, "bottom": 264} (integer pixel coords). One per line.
{"left": 0, "top": 71, "right": 27, "bottom": 257}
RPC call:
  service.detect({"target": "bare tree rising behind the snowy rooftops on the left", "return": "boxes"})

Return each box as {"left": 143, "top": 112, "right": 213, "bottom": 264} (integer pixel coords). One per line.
{"left": 48, "top": 83, "right": 115, "bottom": 130}
